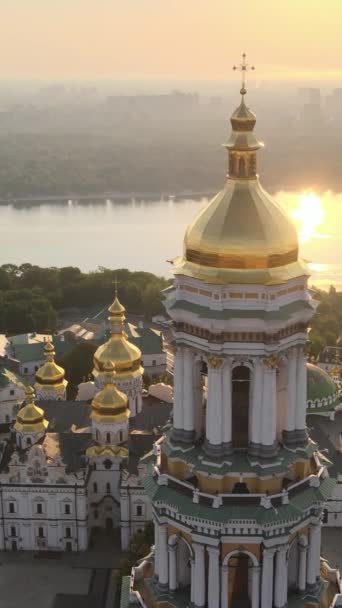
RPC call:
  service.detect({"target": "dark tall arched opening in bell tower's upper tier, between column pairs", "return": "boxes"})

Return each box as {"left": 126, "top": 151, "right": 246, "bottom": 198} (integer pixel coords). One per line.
{"left": 232, "top": 365, "right": 250, "bottom": 448}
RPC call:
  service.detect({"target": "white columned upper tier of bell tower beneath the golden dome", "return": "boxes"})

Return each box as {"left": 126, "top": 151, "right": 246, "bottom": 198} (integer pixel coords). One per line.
{"left": 166, "top": 276, "right": 313, "bottom": 455}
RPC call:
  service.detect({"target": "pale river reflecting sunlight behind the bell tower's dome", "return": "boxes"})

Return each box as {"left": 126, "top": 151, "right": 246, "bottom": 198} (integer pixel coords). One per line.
{"left": 0, "top": 192, "right": 342, "bottom": 288}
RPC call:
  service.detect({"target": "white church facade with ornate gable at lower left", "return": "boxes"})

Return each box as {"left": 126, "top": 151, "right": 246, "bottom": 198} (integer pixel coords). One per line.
{"left": 0, "top": 440, "right": 88, "bottom": 551}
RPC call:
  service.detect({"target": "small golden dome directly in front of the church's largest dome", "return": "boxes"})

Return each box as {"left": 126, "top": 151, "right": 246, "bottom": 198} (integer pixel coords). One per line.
{"left": 91, "top": 361, "right": 130, "bottom": 421}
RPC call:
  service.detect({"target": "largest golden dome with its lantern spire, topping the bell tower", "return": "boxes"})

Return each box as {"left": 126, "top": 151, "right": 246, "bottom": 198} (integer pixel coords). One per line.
{"left": 175, "top": 90, "right": 307, "bottom": 284}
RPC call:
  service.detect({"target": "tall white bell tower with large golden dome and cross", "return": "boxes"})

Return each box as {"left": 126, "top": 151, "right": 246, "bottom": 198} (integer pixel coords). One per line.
{"left": 144, "top": 57, "right": 334, "bottom": 608}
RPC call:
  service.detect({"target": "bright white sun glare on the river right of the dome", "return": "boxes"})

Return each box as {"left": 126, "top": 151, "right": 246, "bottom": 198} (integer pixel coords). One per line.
{"left": 292, "top": 192, "right": 324, "bottom": 243}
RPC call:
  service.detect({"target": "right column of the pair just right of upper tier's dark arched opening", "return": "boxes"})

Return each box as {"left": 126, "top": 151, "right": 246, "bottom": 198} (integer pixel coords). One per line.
{"left": 262, "top": 367, "right": 277, "bottom": 446}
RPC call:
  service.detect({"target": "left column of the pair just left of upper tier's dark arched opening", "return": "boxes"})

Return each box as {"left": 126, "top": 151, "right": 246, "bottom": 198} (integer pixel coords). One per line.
{"left": 206, "top": 356, "right": 223, "bottom": 447}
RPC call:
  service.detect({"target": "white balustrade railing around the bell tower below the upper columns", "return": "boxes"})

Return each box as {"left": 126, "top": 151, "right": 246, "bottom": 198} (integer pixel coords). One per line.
{"left": 154, "top": 465, "right": 327, "bottom": 509}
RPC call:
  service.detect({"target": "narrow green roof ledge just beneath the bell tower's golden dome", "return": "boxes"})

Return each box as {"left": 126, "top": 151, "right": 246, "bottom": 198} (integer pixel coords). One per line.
{"left": 170, "top": 300, "right": 312, "bottom": 321}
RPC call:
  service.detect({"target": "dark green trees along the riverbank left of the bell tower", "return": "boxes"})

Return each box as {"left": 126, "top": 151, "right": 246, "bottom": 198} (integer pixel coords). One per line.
{"left": 0, "top": 263, "right": 169, "bottom": 334}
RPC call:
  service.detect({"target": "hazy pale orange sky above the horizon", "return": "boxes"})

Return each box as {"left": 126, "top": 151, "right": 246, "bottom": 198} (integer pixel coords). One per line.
{"left": 0, "top": 0, "right": 342, "bottom": 79}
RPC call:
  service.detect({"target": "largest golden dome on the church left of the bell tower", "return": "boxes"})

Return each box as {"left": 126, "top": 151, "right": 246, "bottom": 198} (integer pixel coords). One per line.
{"left": 93, "top": 297, "right": 142, "bottom": 376}
